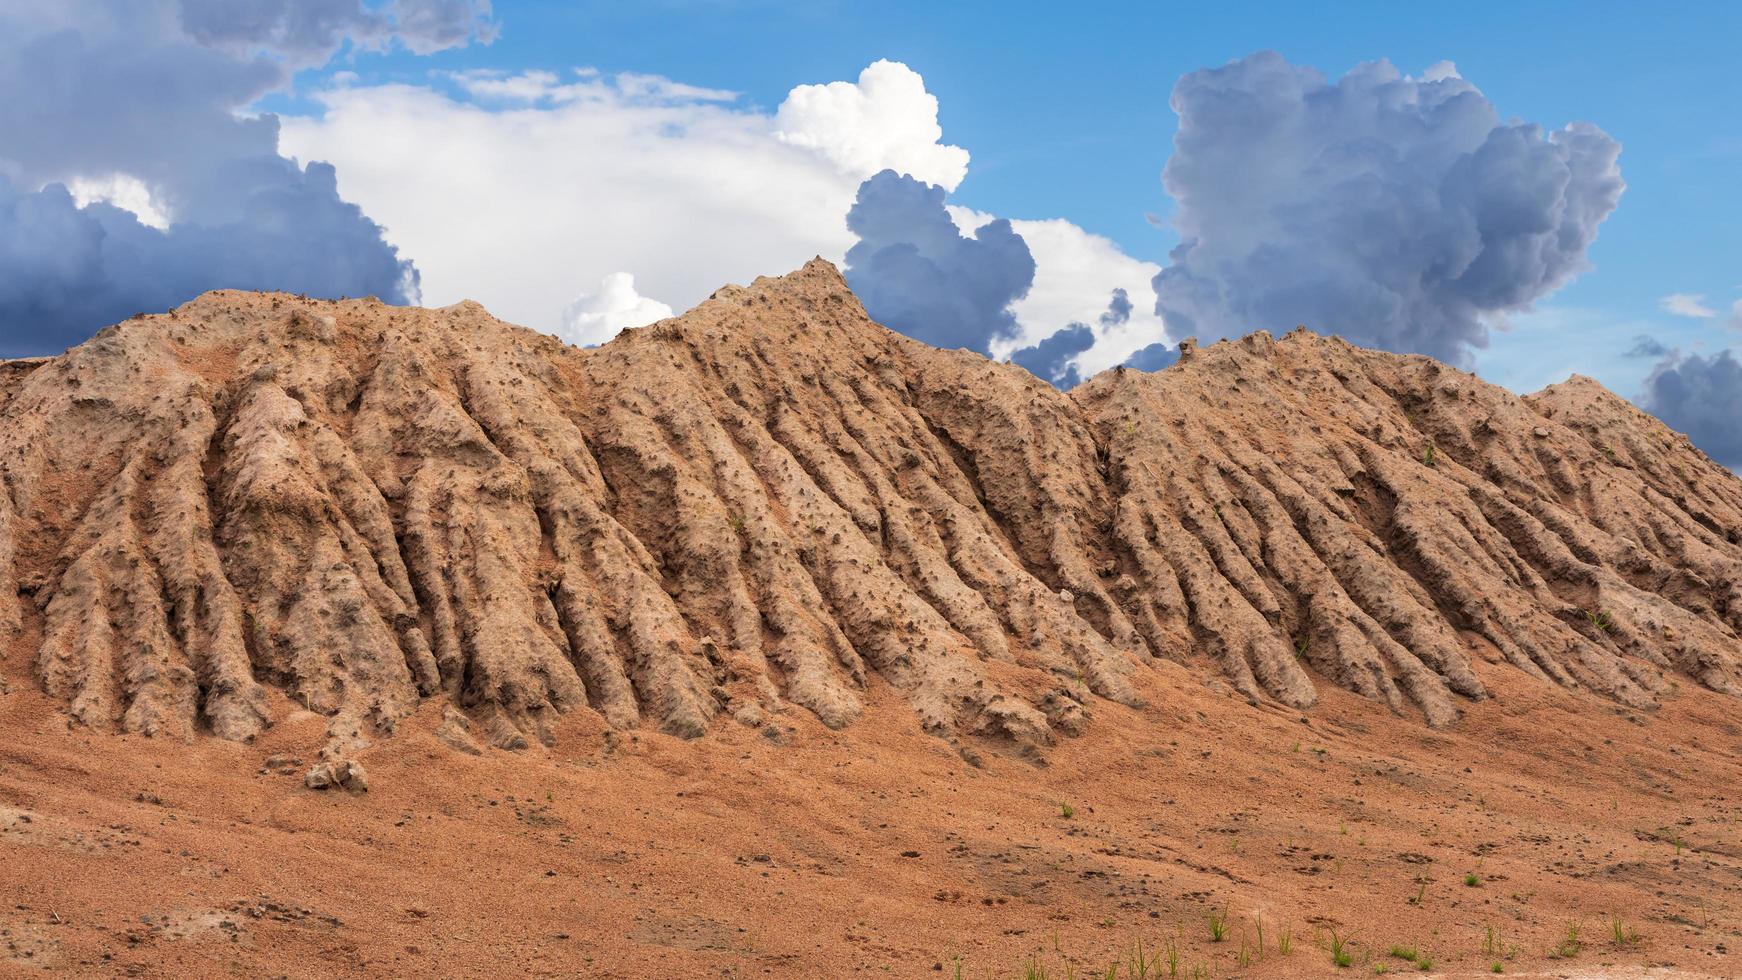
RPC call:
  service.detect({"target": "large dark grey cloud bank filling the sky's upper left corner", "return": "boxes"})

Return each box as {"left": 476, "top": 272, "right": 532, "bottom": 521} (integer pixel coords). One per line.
{"left": 0, "top": 0, "right": 490, "bottom": 355}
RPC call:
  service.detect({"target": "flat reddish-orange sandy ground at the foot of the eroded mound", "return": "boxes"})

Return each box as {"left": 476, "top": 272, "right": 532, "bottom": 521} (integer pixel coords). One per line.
{"left": 0, "top": 640, "right": 1742, "bottom": 978}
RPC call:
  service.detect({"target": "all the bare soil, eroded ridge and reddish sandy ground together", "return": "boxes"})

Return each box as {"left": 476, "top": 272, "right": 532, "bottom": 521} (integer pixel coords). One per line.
{"left": 0, "top": 261, "right": 1742, "bottom": 977}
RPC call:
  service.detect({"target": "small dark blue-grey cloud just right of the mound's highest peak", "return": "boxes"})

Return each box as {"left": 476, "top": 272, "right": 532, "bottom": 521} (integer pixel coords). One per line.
{"left": 847, "top": 171, "right": 1035, "bottom": 353}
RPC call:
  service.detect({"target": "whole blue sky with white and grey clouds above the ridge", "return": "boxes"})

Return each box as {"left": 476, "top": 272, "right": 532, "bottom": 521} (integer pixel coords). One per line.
{"left": 0, "top": 0, "right": 1742, "bottom": 456}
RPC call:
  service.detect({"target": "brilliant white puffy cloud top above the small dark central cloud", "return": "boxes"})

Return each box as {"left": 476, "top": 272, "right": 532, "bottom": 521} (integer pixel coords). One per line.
{"left": 775, "top": 61, "right": 969, "bottom": 190}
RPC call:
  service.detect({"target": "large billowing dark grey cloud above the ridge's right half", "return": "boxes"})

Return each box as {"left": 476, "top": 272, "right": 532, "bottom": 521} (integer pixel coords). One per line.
{"left": 1155, "top": 52, "right": 1625, "bottom": 364}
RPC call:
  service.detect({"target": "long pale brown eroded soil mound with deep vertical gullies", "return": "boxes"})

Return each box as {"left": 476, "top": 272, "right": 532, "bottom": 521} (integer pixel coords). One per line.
{"left": 0, "top": 259, "right": 1742, "bottom": 761}
